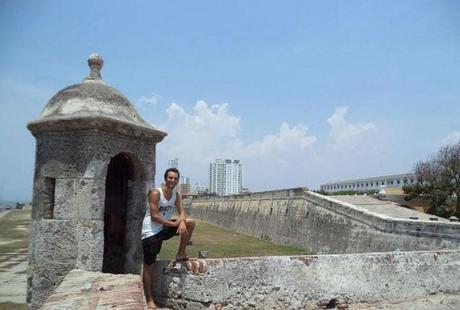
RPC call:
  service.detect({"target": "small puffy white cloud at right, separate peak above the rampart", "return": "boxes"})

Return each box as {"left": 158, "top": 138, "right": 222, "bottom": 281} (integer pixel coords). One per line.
{"left": 327, "top": 107, "right": 376, "bottom": 148}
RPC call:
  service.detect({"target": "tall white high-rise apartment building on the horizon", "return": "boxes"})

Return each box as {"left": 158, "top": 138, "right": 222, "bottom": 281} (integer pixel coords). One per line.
{"left": 209, "top": 159, "right": 243, "bottom": 195}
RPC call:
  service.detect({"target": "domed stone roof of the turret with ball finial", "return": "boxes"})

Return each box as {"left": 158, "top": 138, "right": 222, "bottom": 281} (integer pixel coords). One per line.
{"left": 28, "top": 54, "right": 166, "bottom": 140}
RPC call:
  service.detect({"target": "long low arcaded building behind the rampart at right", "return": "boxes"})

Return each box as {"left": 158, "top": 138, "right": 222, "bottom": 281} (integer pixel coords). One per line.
{"left": 320, "top": 173, "right": 415, "bottom": 193}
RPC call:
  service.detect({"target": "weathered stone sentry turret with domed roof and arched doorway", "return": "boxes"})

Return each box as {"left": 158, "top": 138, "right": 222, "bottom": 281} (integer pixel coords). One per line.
{"left": 27, "top": 54, "right": 166, "bottom": 309}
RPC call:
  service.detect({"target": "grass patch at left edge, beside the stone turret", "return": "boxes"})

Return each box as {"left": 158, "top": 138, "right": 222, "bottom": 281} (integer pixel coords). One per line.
{"left": 0, "top": 210, "right": 31, "bottom": 256}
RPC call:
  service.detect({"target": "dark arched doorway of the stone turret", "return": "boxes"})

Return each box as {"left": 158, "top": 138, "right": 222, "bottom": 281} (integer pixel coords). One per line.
{"left": 102, "top": 153, "right": 146, "bottom": 274}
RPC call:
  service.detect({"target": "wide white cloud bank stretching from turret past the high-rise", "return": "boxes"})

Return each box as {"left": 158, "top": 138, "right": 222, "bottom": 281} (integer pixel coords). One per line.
{"left": 144, "top": 101, "right": 392, "bottom": 191}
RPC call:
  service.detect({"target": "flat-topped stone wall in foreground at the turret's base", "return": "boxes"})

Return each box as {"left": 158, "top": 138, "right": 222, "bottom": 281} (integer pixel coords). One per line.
{"left": 41, "top": 269, "right": 146, "bottom": 310}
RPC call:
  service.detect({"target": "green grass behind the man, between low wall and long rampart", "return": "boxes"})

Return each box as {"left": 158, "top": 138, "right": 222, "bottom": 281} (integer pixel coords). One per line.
{"left": 158, "top": 221, "right": 312, "bottom": 259}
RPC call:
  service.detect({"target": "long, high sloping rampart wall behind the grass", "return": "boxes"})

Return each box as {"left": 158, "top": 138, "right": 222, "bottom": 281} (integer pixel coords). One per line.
{"left": 188, "top": 188, "right": 460, "bottom": 253}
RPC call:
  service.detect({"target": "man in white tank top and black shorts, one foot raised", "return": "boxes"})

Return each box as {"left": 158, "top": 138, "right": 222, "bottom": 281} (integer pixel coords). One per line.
{"left": 142, "top": 168, "right": 195, "bottom": 309}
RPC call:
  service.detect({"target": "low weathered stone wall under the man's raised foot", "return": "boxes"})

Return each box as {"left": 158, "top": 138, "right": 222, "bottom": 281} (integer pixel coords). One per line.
{"left": 153, "top": 251, "right": 460, "bottom": 310}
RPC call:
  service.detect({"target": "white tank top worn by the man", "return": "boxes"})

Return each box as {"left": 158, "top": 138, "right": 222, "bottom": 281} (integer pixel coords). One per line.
{"left": 141, "top": 188, "right": 177, "bottom": 239}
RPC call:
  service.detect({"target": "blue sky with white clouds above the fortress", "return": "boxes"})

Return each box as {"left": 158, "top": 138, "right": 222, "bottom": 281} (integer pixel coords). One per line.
{"left": 0, "top": 0, "right": 460, "bottom": 200}
